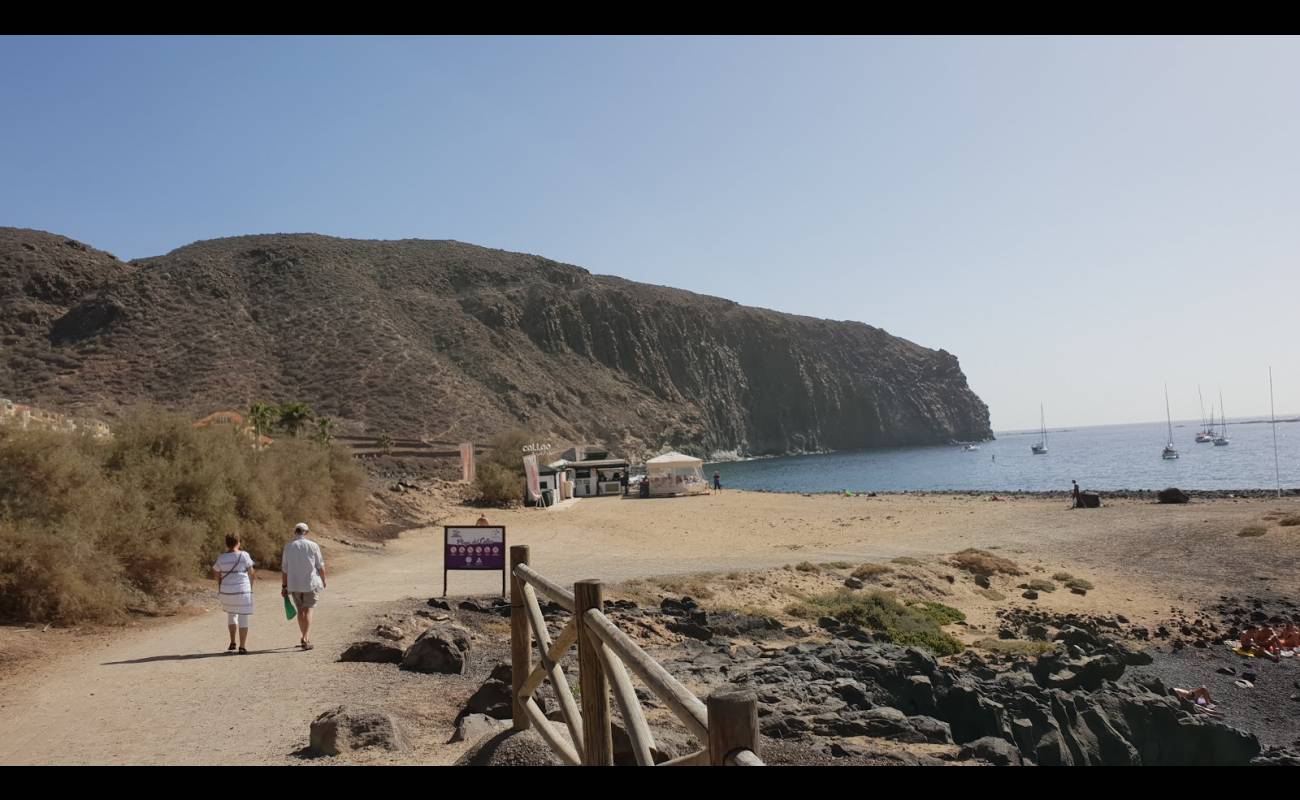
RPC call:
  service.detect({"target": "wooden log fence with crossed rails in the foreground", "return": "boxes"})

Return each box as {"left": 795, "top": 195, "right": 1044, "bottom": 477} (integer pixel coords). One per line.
{"left": 510, "top": 545, "right": 763, "bottom": 766}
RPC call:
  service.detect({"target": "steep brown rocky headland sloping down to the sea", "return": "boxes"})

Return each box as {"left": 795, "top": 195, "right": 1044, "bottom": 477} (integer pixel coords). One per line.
{"left": 0, "top": 229, "right": 991, "bottom": 454}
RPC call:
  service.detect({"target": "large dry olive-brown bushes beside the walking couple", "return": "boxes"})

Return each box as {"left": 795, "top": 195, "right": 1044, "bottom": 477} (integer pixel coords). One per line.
{"left": 0, "top": 412, "right": 365, "bottom": 623}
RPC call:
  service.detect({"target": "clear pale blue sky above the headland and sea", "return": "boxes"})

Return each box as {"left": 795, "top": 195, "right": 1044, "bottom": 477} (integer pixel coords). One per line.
{"left": 0, "top": 38, "right": 1300, "bottom": 429}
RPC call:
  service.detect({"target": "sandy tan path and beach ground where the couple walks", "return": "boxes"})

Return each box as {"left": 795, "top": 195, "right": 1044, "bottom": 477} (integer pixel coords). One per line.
{"left": 0, "top": 493, "right": 1300, "bottom": 764}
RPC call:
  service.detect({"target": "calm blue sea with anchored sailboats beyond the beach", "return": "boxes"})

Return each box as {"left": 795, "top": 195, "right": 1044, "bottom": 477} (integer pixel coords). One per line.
{"left": 706, "top": 420, "right": 1300, "bottom": 492}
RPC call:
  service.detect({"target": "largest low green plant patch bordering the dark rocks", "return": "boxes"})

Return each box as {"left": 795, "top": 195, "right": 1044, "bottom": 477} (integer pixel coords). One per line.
{"left": 785, "top": 589, "right": 965, "bottom": 656}
